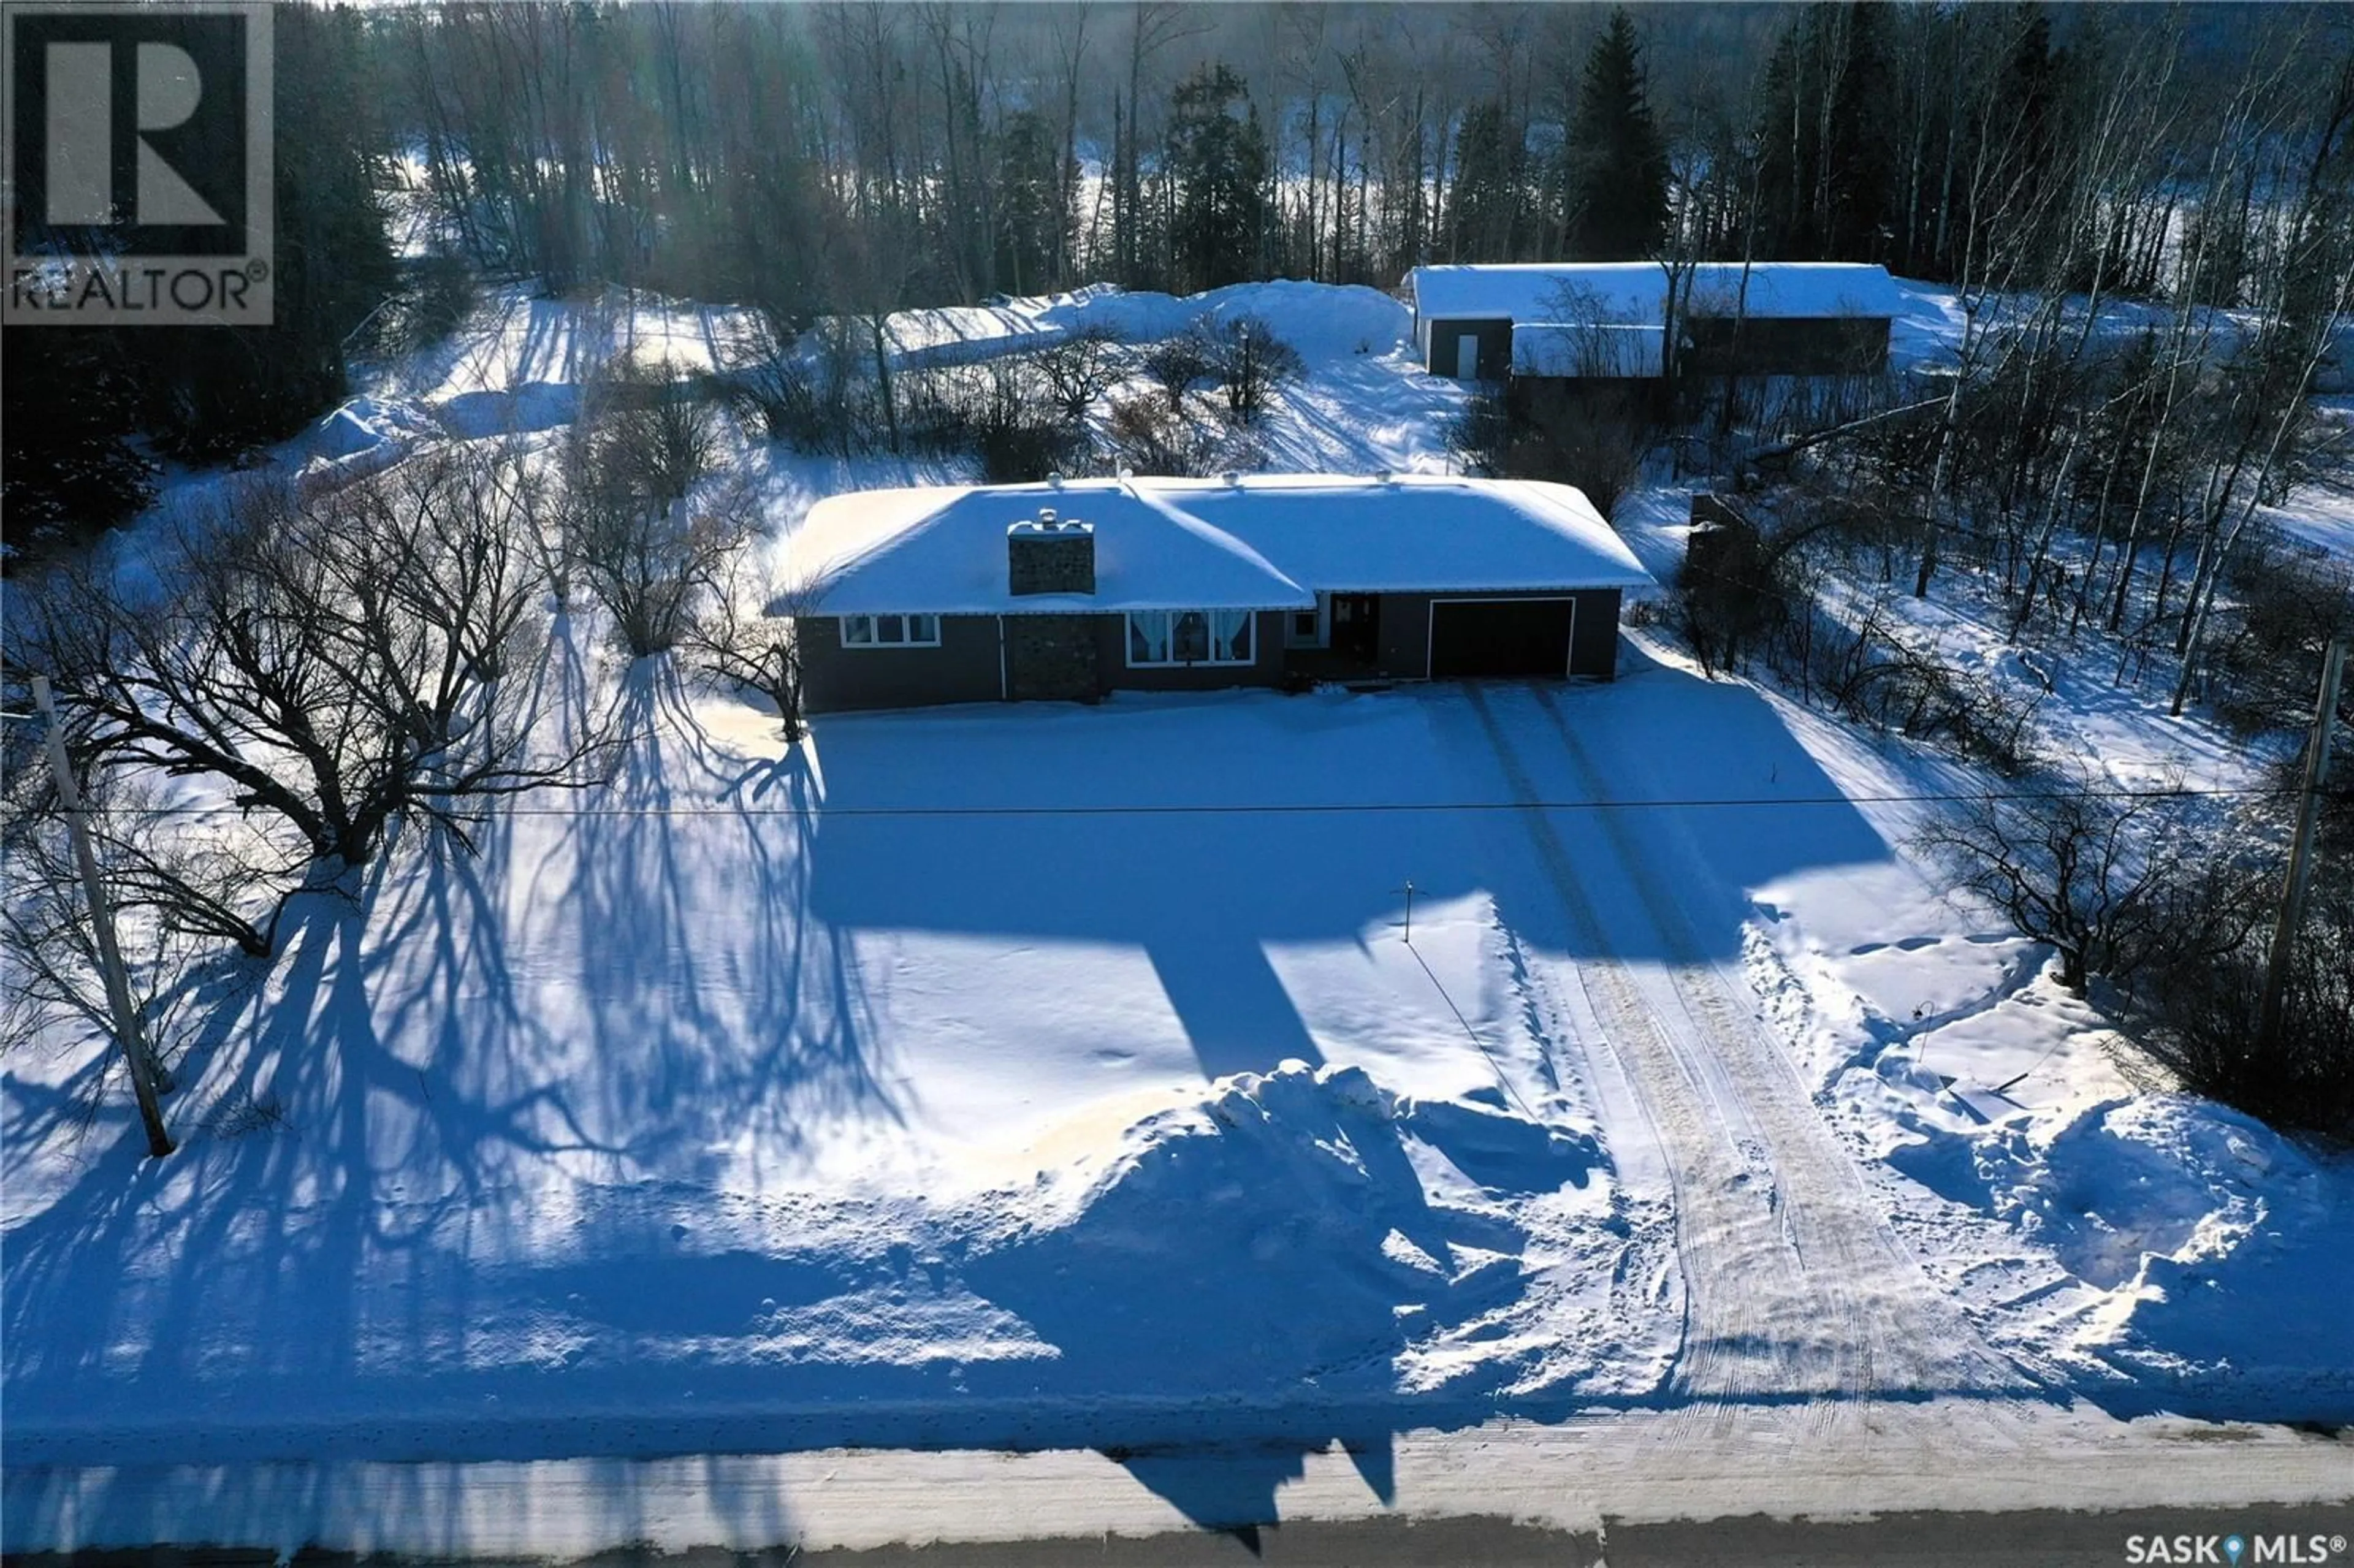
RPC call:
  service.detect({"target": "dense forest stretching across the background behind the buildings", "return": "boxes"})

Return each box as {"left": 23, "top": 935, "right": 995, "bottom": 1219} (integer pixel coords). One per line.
{"left": 5, "top": 0, "right": 2349, "bottom": 551}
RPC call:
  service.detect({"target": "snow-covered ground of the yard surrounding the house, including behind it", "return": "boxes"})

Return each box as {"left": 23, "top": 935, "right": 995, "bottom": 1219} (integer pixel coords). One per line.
{"left": 0, "top": 266, "right": 2354, "bottom": 1549}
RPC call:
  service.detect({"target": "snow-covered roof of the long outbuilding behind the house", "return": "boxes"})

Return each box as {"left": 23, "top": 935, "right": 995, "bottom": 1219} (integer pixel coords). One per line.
{"left": 1405, "top": 261, "right": 1905, "bottom": 325}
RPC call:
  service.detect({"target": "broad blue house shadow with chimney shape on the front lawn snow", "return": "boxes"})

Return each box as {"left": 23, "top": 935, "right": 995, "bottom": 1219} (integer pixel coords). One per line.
{"left": 810, "top": 652, "right": 1888, "bottom": 1050}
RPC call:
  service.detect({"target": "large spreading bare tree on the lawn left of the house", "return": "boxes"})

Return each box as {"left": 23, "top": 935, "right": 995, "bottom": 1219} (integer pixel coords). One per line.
{"left": 9, "top": 450, "right": 600, "bottom": 932}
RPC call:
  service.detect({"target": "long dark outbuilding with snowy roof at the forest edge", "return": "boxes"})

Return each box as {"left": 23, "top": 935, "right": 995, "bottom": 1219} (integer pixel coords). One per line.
{"left": 1405, "top": 261, "right": 1905, "bottom": 381}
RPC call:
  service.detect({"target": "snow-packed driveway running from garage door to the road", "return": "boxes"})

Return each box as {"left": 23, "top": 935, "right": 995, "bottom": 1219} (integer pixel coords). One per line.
{"left": 1462, "top": 685, "right": 2034, "bottom": 1401}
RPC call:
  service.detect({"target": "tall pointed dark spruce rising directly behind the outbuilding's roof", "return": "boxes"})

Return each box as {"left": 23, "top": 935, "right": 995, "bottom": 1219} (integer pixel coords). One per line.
{"left": 1563, "top": 9, "right": 1667, "bottom": 261}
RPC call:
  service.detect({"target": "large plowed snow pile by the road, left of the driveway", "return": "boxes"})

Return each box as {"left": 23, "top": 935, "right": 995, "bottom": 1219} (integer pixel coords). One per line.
{"left": 946, "top": 1062, "right": 1674, "bottom": 1403}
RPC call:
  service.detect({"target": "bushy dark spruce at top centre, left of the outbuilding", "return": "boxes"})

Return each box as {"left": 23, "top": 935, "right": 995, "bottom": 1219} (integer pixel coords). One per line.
{"left": 1168, "top": 64, "right": 1271, "bottom": 292}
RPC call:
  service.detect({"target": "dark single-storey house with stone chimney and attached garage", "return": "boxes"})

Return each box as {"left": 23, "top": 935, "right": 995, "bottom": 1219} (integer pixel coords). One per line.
{"left": 779, "top": 463, "right": 1653, "bottom": 714}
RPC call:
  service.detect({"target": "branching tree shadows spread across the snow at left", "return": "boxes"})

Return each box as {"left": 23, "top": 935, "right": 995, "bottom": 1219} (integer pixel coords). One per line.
{"left": 0, "top": 654, "right": 892, "bottom": 1462}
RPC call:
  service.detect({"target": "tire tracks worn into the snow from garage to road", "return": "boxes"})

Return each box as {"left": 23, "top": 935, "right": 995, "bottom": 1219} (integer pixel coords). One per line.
{"left": 1464, "top": 688, "right": 2034, "bottom": 1425}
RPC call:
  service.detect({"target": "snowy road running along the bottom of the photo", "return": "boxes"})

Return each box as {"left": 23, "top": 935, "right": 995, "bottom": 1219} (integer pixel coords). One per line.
{"left": 0, "top": 1398, "right": 2354, "bottom": 1568}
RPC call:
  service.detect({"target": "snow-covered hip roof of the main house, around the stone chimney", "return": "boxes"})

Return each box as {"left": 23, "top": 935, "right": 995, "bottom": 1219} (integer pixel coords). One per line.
{"left": 787, "top": 473, "right": 1653, "bottom": 614}
